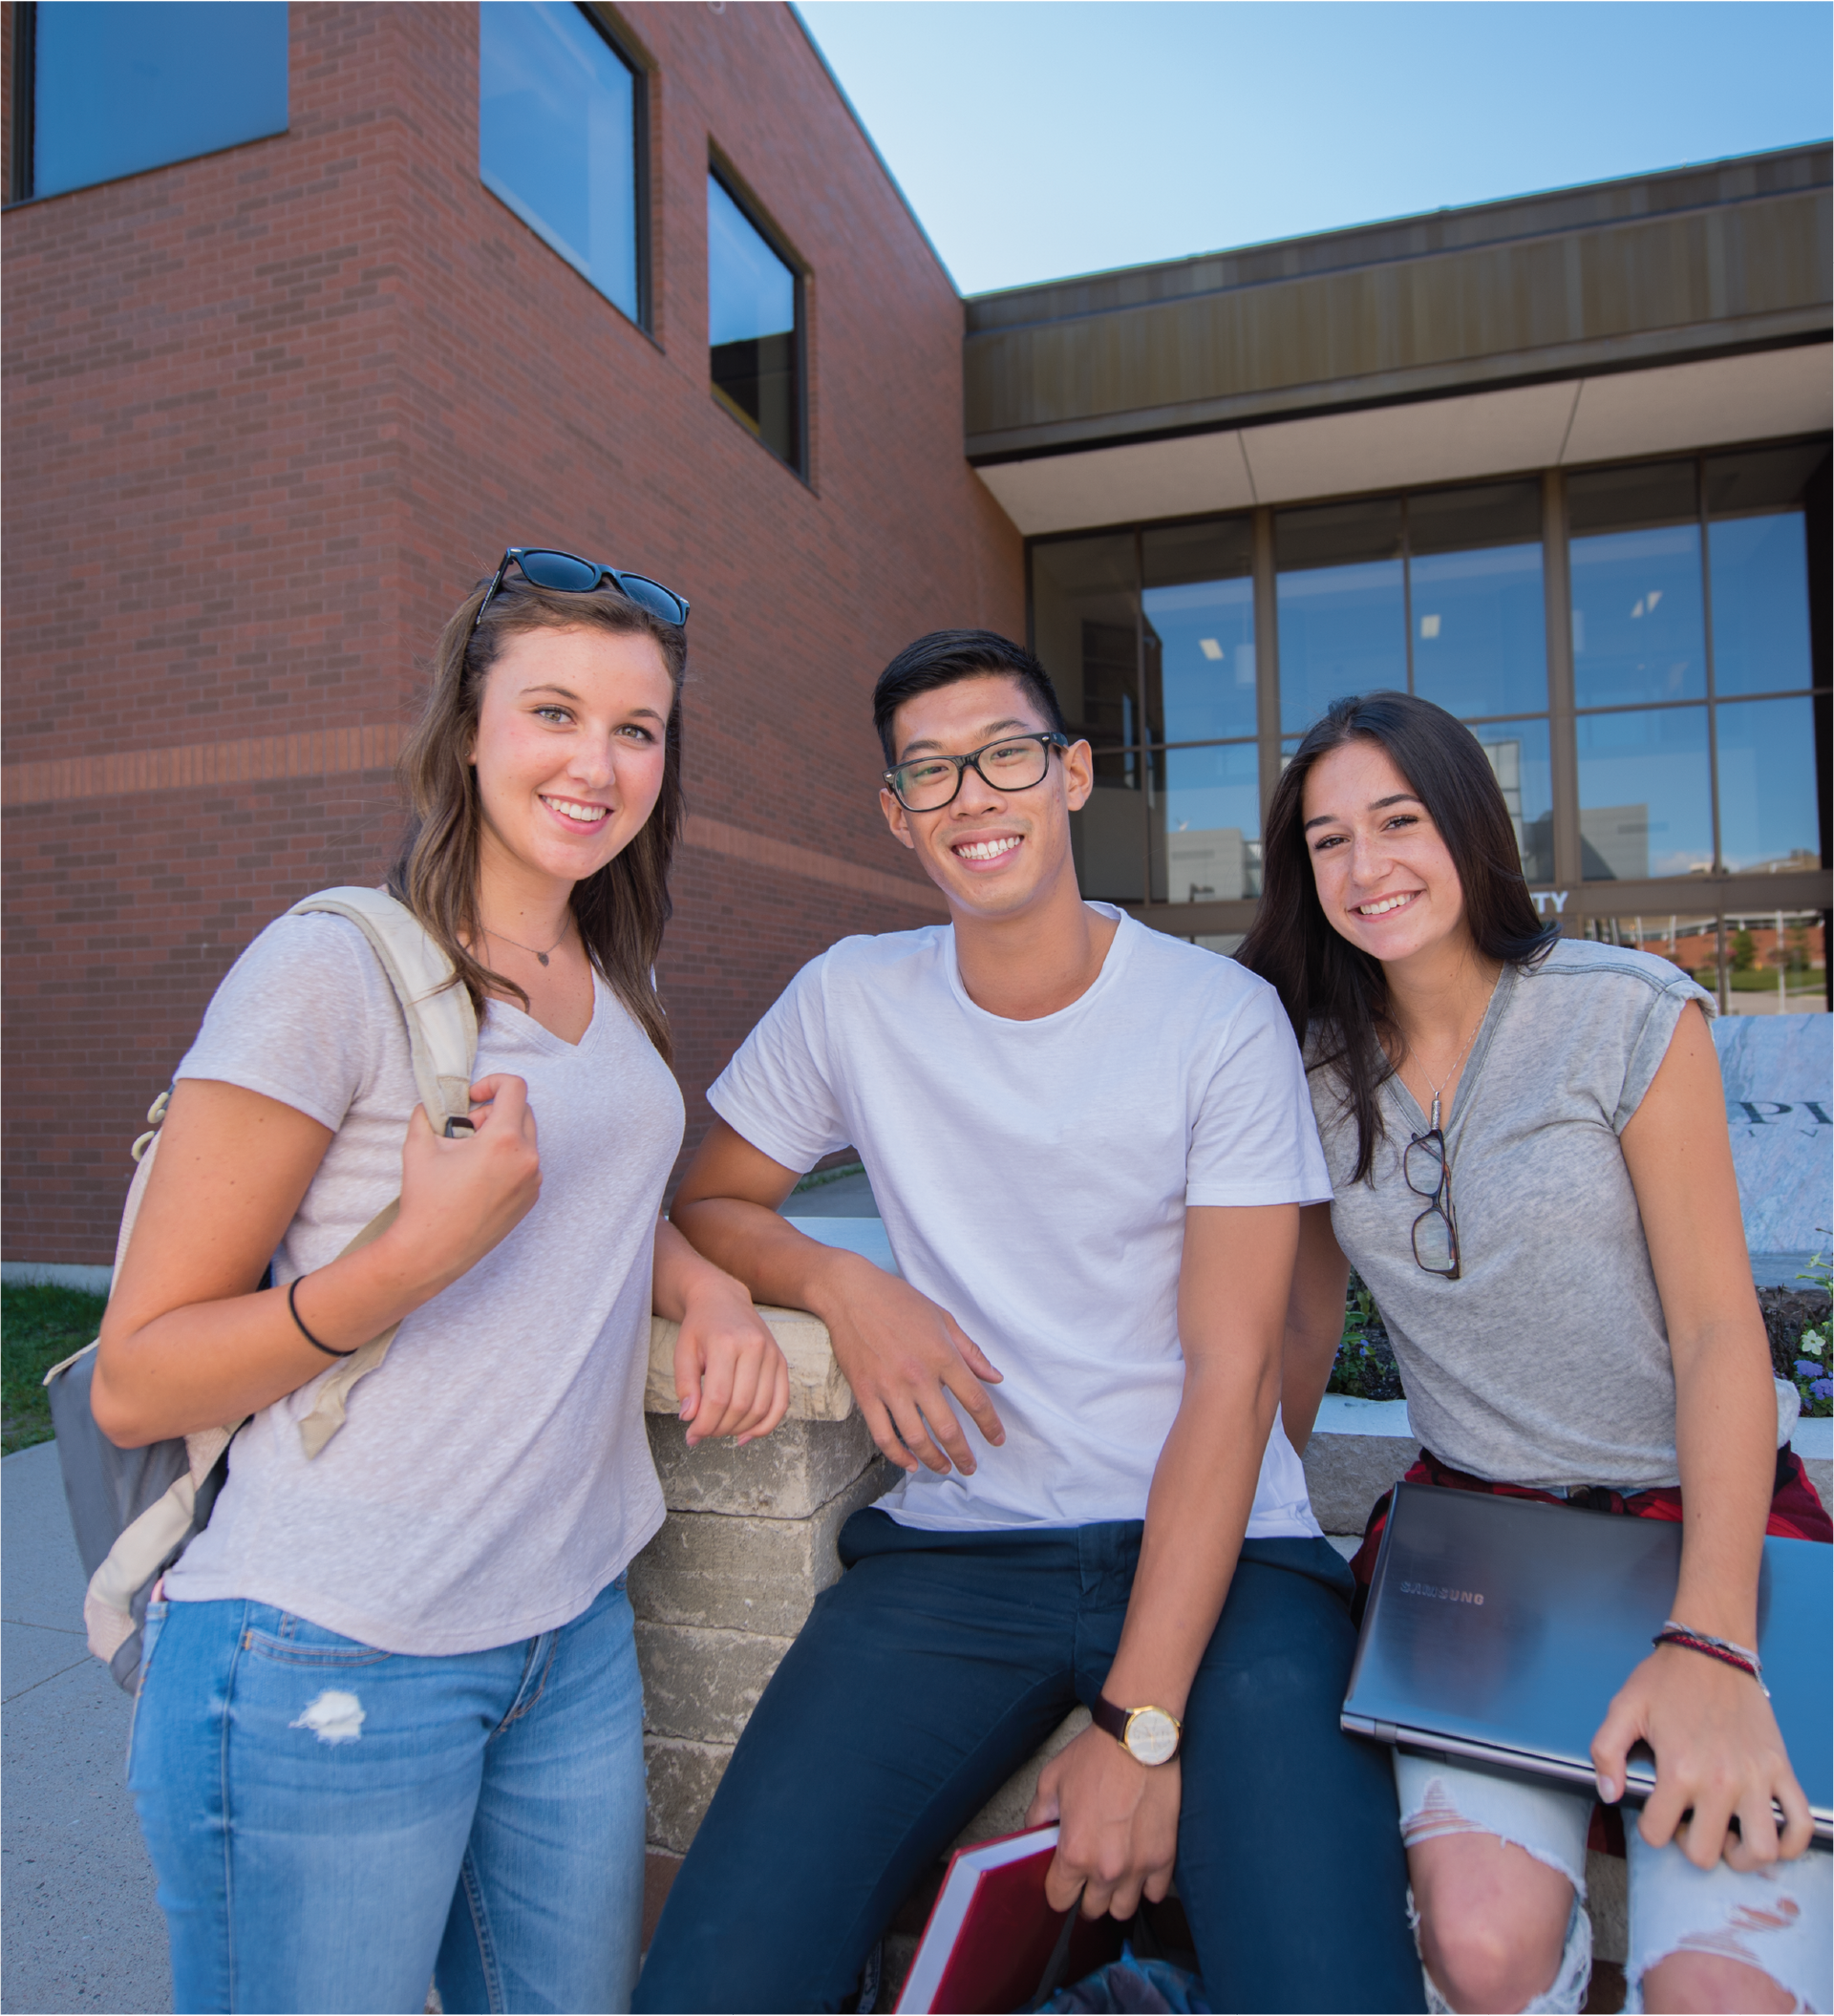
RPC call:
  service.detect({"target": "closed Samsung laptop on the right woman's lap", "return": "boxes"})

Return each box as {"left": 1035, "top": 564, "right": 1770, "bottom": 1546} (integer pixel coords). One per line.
{"left": 1344, "top": 1484, "right": 1834, "bottom": 1840}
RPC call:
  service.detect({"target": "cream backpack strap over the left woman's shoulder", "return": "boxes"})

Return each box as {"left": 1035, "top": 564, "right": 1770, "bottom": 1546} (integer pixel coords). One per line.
{"left": 288, "top": 889, "right": 478, "bottom": 1457}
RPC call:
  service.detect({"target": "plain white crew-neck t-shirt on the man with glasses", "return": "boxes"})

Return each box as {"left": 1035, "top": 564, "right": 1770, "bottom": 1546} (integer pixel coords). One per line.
{"left": 708, "top": 903, "right": 1331, "bottom": 1539}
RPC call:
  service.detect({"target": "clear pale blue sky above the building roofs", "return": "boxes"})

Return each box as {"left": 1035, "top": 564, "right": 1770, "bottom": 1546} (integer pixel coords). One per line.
{"left": 799, "top": 0, "right": 1834, "bottom": 294}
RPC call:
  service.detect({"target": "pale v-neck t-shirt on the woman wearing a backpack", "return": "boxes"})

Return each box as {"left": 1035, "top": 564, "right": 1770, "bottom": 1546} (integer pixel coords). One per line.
{"left": 165, "top": 915, "right": 683, "bottom": 1653}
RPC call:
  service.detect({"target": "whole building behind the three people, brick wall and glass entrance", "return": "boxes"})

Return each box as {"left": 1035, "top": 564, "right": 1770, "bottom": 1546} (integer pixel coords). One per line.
{"left": 0, "top": 0, "right": 1834, "bottom": 1268}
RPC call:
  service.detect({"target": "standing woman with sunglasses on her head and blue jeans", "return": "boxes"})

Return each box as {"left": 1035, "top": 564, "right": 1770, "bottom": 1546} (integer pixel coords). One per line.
{"left": 91, "top": 548, "right": 788, "bottom": 2016}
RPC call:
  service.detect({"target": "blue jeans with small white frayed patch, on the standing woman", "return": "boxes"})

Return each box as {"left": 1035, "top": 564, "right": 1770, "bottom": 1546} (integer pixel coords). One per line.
{"left": 127, "top": 1579, "right": 645, "bottom": 2016}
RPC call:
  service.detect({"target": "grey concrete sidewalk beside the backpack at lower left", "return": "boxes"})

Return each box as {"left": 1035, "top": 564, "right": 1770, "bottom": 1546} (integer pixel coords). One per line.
{"left": 0, "top": 1441, "right": 171, "bottom": 2016}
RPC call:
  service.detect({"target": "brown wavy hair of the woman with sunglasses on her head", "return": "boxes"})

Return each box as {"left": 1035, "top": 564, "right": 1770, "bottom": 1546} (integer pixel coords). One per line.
{"left": 389, "top": 575, "right": 687, "bottom": 1060}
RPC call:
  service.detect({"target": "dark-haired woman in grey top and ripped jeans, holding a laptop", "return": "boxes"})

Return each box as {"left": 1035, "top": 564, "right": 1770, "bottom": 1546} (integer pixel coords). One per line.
{"left": 1240, "top": 693, "right": 1834, "bottom": 2016}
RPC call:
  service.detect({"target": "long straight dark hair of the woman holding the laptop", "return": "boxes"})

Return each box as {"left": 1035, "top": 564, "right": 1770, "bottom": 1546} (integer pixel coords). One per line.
{"left": 1235, "top": 693, "right": 1560, "bottom": 1181}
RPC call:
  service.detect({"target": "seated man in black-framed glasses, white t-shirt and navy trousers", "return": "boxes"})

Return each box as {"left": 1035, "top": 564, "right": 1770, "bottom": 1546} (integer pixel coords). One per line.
{"left": 635, "top": 631, "right": 1420, "bottom": 2016}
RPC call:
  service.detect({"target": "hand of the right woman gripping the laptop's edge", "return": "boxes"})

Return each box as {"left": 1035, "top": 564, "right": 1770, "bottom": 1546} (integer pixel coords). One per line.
{"left": 1592, "top": 1645, "right": 1814, "bottom": 1869}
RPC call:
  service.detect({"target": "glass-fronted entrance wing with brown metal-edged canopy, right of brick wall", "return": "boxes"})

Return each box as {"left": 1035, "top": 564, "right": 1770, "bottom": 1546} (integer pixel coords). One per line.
{"left": 983, "top": 147, "right": 1834, "bottom": 1004}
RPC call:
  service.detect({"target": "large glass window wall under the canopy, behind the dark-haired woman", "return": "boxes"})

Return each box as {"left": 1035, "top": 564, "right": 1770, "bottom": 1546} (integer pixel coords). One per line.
{"left": 1030, "top": 439, "right": 1834, "bottom": 992}
